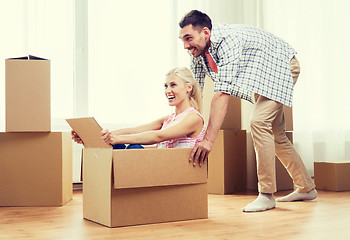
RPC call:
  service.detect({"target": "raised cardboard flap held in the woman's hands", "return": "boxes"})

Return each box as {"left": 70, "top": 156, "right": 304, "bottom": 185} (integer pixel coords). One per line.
{"left": 66, "top": 117, "right": 112, "bottom": 148}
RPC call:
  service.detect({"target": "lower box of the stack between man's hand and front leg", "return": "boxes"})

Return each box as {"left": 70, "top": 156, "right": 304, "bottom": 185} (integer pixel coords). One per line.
{"left": 208, "top": 130, "right": 247, "bottom": 194}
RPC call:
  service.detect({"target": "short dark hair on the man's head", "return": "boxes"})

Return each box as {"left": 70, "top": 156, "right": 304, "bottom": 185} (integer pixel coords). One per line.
{"left": 179, "top": 10, "right": 212, "bottom": 31}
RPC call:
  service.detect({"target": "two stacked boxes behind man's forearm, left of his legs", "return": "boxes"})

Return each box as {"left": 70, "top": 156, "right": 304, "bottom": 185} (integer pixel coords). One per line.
{"left": 203, "top": 77, "right": 247, "bottom": 194}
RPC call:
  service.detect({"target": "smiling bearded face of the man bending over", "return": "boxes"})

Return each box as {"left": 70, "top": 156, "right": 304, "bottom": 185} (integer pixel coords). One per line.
{"left": 179, "top": 24, "right": 210, "bottom": 58}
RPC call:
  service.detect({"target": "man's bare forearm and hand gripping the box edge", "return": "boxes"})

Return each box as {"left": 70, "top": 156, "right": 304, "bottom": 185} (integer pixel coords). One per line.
{"left": 189, "top": 92, "right": 230, "bottom": 166}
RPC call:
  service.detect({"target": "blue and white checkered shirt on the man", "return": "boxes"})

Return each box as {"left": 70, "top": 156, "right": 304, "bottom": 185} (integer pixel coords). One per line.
{"left": 191, "top": 24, "right": 296, "bottom": 106}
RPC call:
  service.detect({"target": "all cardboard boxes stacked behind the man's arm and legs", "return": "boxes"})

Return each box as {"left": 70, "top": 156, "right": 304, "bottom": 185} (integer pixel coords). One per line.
{"left": 203, "top": 75, "right": 293, "bottom": 194}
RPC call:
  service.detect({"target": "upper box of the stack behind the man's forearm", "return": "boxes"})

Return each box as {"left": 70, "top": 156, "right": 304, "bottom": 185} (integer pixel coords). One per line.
{"left": 202, "top": 77, "right": 241, "bottom": 130}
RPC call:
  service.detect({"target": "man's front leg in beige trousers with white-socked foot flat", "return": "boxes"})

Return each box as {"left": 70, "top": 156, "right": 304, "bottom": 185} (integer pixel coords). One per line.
{"left": 243, "top": 96, "right": 283, "bottom": 212}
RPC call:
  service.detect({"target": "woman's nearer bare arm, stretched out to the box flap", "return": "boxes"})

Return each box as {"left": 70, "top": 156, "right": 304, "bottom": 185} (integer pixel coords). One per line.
{"left": 101, "top": 113, "right": 204, "bottom": 145}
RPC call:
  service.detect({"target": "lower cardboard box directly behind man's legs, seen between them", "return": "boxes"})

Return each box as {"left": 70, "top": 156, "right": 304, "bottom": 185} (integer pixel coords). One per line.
{"left": 247, "top": 132, "right": 294, "bottom": 191}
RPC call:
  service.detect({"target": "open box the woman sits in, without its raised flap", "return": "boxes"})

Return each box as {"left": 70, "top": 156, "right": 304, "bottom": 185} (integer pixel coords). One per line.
{"left": 83, "top": 148, "right": 208, "bottom": 227}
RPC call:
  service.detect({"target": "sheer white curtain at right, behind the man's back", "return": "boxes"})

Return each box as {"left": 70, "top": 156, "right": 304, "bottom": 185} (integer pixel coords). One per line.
{"left": 263, "top": 0, "right": 350, "bottom": 174}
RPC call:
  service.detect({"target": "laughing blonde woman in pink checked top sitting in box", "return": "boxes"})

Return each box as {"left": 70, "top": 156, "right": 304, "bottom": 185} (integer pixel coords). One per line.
{"left": 72, "top": 68, "right": 205, "bottom": 149}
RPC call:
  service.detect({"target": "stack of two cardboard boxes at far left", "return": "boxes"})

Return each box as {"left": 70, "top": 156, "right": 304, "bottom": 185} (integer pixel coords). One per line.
{"left": 0, "top": 56, "right": 72, "bottom": 206}
